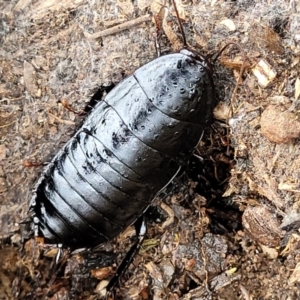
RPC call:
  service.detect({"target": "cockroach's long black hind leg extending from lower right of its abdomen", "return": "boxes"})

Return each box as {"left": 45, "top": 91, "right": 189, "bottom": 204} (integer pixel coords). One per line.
{"left": 106, "top": 215, "right": 147, "bottom": 294}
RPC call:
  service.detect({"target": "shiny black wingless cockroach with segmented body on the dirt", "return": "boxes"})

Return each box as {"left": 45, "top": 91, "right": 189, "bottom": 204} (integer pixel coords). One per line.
{"left": 21, "top": 0, "right": 216, "bottom": 289}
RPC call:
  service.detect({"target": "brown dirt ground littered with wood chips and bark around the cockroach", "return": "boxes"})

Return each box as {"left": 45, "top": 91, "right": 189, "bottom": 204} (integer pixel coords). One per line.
{"left": 0, "top": 0, "right": 300, "bottom": 300}
